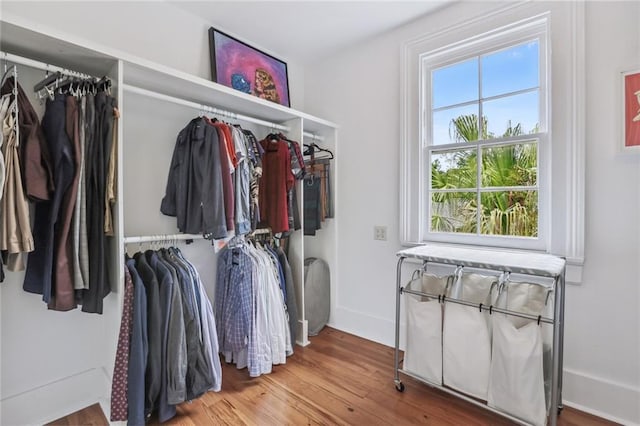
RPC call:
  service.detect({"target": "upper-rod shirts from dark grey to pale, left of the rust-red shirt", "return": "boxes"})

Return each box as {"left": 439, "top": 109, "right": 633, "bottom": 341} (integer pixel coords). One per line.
{"left": 160, "top": 117, "right": 262, "bottom": 239}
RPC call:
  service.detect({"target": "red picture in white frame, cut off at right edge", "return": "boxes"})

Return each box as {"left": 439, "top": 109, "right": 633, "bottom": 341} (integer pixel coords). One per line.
{"left": 622, "top": 70, "right": 640, "bottom": 152}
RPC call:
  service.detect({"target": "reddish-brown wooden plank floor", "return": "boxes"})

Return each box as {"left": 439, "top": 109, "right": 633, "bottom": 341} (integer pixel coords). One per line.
{"left": 51, "top": 327, "right": 613, "bottom": 426}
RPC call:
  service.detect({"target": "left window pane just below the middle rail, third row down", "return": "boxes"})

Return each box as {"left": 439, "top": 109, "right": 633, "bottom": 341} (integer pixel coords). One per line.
{"left": 431, "top": 149, "right": 478, "bottom": 189}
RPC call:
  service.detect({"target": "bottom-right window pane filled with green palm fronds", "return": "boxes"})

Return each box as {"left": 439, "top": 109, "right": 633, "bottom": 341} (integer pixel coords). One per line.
{"left": 480, "top": 191, "right": 538, "bottom": 237}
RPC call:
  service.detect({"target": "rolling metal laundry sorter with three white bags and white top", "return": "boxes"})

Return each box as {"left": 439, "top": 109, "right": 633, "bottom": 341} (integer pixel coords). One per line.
{"left": 394, "top": 245, "right": 566, "bottom": 426}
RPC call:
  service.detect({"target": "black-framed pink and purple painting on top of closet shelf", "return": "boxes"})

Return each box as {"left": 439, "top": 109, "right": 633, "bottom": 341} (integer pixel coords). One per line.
{"left": 209, "top": 28, "right": 291, "bottom": 107}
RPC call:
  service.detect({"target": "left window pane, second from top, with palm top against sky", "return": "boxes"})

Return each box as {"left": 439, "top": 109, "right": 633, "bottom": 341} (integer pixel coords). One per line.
{"left": 431, "top": 105, "right": 478, "bottom": 145}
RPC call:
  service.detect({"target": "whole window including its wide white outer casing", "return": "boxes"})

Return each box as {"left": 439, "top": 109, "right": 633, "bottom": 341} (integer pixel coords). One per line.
{"left": 399, "top": 2, "right": 586, "bottom": 283}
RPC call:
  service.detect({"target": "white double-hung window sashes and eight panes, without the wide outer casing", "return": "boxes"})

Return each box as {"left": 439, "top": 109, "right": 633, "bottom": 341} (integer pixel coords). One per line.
{"left": 420, "top": 36, "right": 548, "bottom": 248}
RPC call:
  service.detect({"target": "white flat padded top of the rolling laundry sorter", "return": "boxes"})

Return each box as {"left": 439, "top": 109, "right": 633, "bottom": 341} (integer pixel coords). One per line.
{"left": 397, "top": 245, "right": 566, "bottom": 278}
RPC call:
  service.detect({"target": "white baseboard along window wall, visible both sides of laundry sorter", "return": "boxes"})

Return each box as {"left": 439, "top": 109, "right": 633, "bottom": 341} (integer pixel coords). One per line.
{"left": 330, "top": 307, "right": 640, "bottom": 426}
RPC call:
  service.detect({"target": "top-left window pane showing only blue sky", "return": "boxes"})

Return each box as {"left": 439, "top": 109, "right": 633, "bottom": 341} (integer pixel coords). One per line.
{"left": 431, "top": 58, "right": 479, "bottom": 109}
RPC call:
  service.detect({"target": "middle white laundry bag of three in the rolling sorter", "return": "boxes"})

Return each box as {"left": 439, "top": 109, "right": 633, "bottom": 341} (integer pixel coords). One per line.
{"left": 442, "top": 274, "right": 498, "bottom": 400}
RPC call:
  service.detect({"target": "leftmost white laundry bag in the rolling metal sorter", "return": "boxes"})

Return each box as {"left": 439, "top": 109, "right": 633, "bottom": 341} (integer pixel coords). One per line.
{"left": 403, "top": 274, "right": 448, "bottom": 385}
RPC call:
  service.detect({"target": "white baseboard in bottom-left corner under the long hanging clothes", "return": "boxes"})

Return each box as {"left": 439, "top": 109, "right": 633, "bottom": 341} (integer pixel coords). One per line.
{"left": 0, "top": 368, "right": 109, "bottom": 425}
